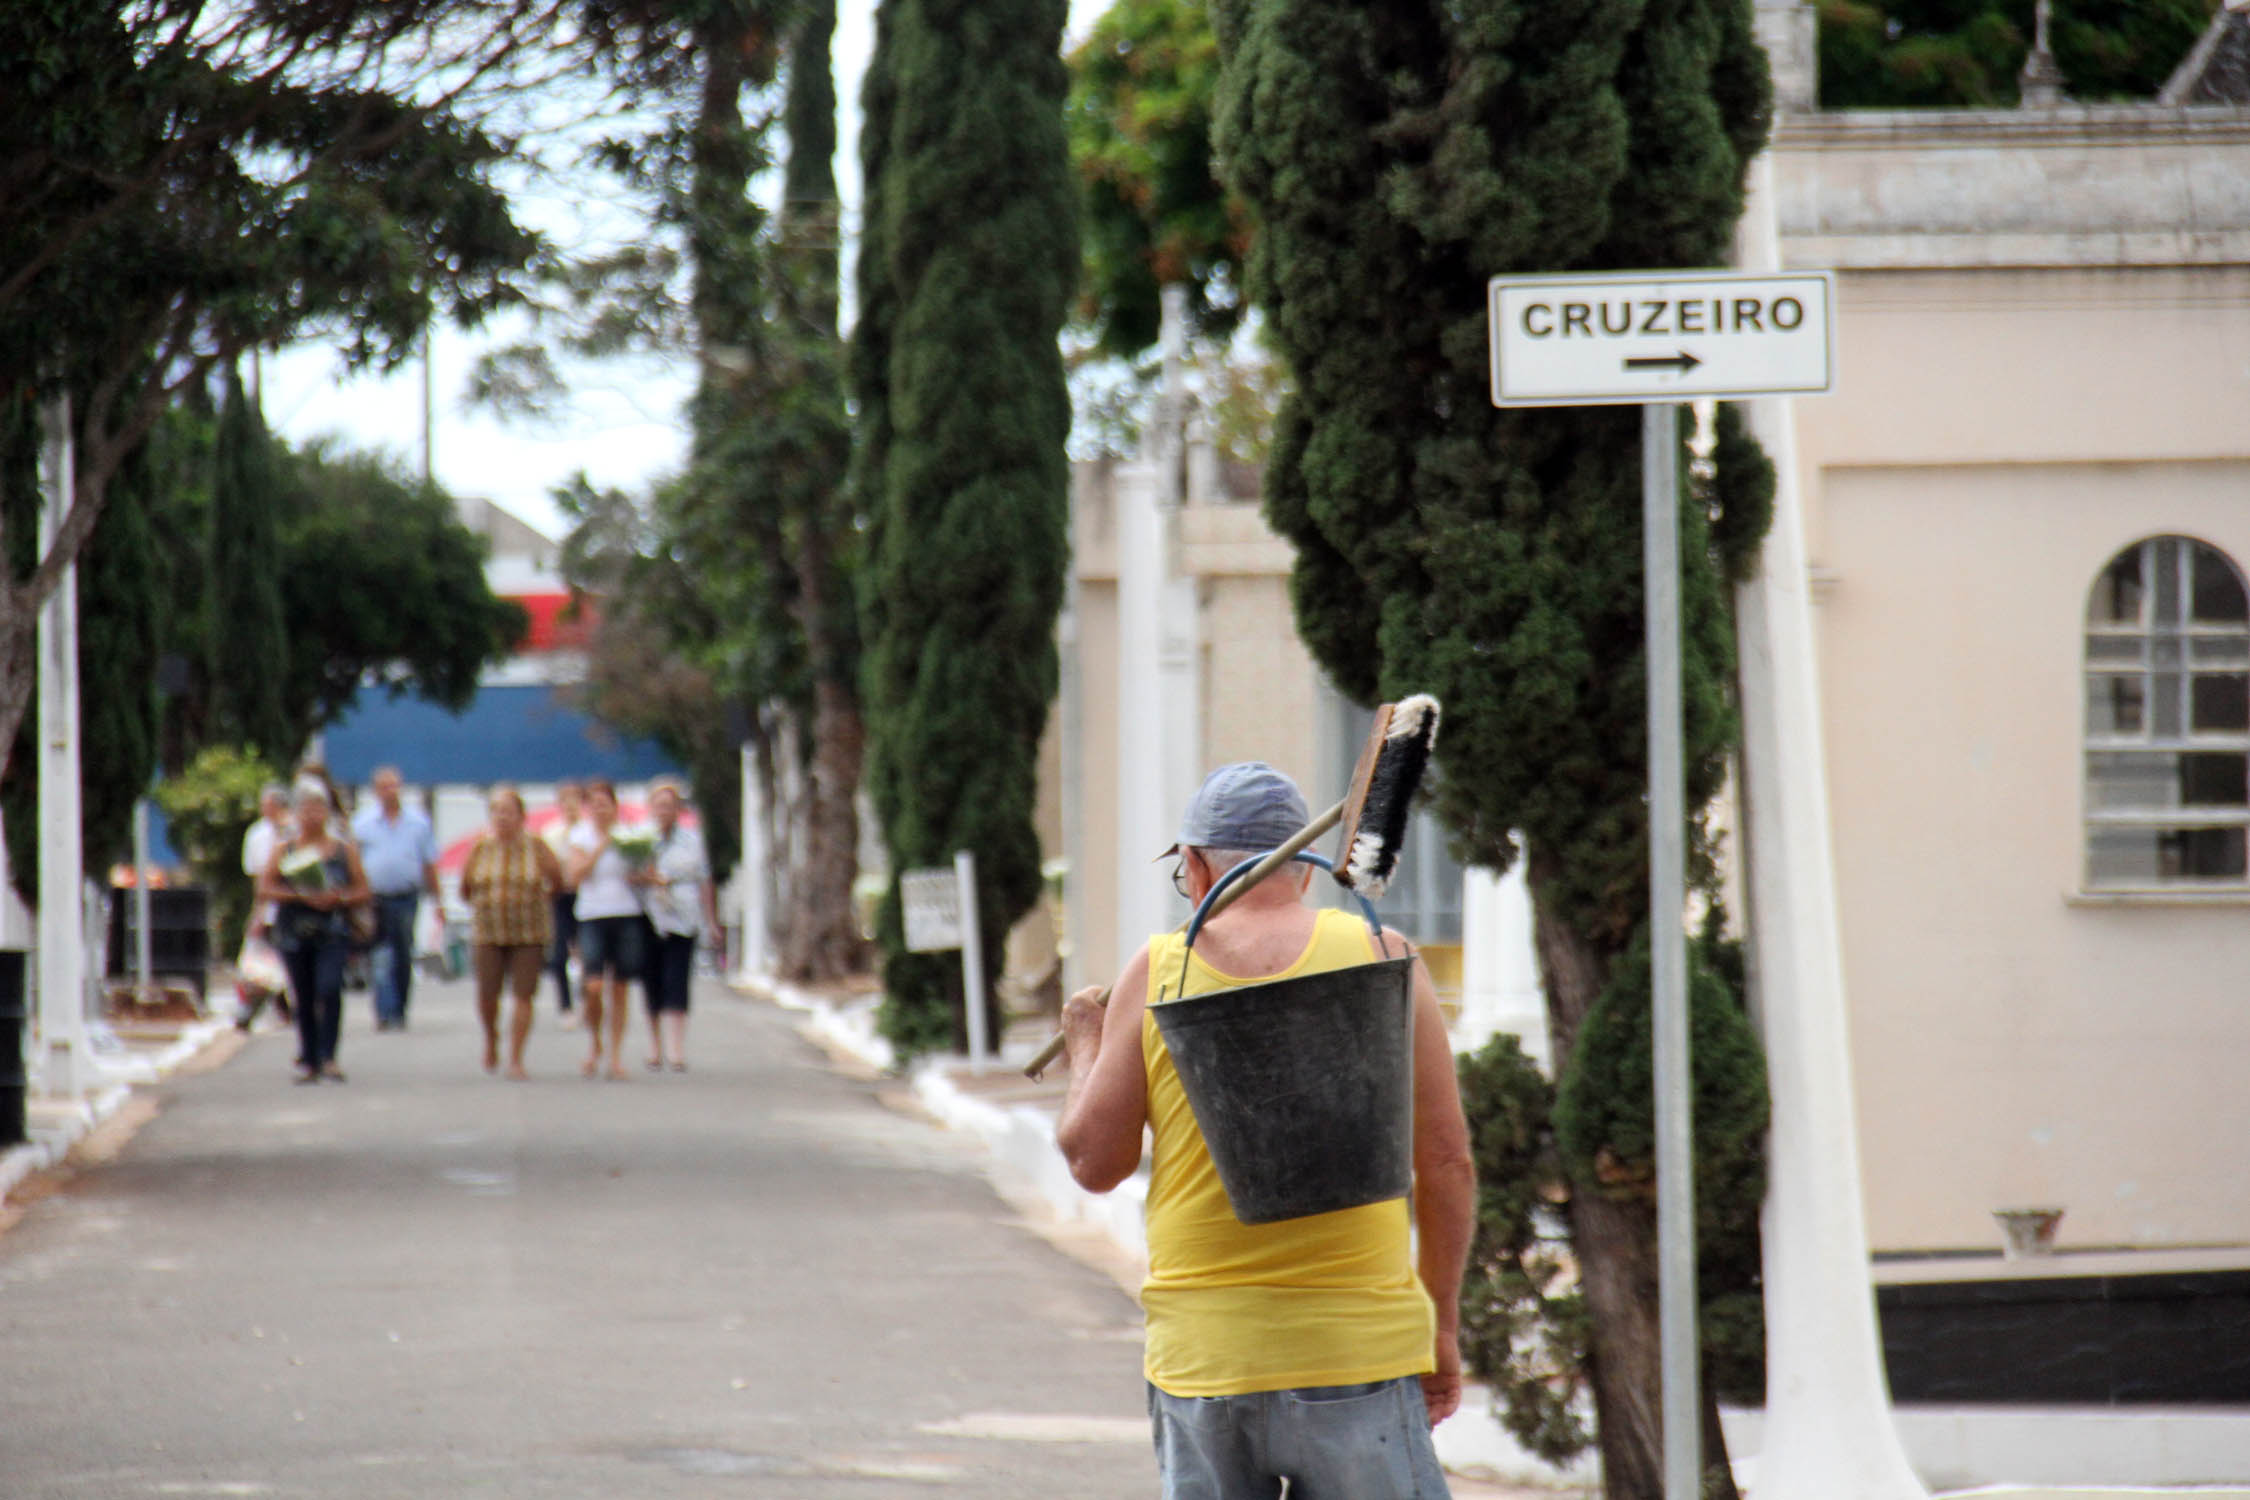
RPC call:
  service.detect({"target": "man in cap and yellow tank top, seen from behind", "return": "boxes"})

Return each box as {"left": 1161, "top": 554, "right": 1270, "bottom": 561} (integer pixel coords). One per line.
{"left": 1055, "top": 760, "right": 1476, "bottom": 1500}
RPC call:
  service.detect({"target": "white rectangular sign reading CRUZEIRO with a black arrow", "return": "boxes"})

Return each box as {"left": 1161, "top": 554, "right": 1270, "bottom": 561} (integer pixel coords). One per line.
{"left": 1490, "top": 270, "right": 1834, "bottom": 407}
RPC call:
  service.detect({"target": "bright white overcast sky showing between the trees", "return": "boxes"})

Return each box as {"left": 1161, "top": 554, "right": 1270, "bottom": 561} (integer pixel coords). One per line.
{"left": 263, "top": 0, "right": 1109, "bottom": 546}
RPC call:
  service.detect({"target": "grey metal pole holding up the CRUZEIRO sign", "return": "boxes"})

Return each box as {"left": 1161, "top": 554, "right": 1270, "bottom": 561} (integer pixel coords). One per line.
{"left": 1640, "top": 403, "right": 1703, "bottom": 1500}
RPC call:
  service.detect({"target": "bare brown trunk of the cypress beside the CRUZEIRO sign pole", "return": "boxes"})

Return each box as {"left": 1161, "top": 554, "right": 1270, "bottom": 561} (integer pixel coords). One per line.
{"left": 1528, "top": 850, "right": 1737, "bottom": 1500}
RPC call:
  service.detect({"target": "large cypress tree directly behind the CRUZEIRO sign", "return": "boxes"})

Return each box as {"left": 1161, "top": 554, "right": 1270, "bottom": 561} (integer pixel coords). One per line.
{"left": 1213, "top": 0, "right": 1769, "bottom": 1500}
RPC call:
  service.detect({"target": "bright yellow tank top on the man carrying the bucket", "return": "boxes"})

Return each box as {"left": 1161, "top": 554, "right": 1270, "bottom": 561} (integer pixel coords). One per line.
{"left": 1141, "top": 911, "right": 1436, "bottom": 1397}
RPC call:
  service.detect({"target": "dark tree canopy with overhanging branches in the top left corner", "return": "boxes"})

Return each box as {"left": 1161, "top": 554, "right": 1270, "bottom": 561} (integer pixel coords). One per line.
{"left": 0, "top": 0, "right": 538, "bottom": 787}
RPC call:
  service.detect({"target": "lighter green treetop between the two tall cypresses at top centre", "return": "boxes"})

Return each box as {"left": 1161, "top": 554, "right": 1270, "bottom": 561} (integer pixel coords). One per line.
{"left": 1064, "top": 0, "right": 1251, "bottom": 360}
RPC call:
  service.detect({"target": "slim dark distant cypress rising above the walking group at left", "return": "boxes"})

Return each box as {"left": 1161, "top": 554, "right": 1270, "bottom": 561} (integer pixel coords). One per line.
{"left": 207, "top": 364, "right": 297, "bottom": 765}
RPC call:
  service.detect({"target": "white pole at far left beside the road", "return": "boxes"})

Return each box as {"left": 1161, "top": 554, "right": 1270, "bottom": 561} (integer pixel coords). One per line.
{"left": 38, "top": 391, "right": 92, "bottom": 1100}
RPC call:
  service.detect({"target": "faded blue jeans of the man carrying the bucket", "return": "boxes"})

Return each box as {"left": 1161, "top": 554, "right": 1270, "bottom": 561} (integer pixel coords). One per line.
{"left": 1148, "top": 1374, "right": 1449, "bottom": 1500}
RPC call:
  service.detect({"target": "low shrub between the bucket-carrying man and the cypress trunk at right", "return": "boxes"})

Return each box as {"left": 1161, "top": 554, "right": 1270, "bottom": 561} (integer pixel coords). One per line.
{"left": 1456, "top": 1032, "right": 1593, "bottom": 1464}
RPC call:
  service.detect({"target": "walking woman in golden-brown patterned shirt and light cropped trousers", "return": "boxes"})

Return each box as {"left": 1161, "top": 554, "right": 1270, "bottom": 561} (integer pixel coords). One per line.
{"left": 461, "top": 785, "right": 563, "bottom": 1079}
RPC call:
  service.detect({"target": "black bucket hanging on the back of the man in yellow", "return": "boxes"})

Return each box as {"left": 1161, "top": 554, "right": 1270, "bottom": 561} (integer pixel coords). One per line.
{"left": 1150, "top": 958, "right": 1413, "bottom": 1223}
